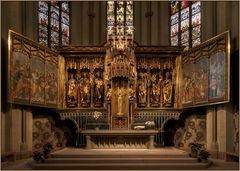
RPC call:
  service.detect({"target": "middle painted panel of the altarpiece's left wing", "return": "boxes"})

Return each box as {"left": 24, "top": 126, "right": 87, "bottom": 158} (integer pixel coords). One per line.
{"left": 31, "top": 58, "right": 45, "bottom": 104}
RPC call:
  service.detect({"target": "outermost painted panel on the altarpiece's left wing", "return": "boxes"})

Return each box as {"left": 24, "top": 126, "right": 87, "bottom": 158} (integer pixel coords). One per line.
{"left": 13, "top": 51, "right": 30, "bottom": 102}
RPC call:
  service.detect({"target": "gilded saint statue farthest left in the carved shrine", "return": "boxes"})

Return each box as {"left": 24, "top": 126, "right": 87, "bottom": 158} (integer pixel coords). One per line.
{"left": 67, "top": 74, "right": 77, "bottom": 107}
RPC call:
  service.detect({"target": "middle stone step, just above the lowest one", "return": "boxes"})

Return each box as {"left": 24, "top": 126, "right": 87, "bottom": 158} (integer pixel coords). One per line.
{"left": 45, "top": 157, "right": 197, "bottom": 164}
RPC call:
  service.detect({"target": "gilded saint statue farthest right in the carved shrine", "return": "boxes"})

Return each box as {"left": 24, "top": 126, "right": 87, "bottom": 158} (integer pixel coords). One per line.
{"left": 163, "top": 72, "right": 173, "bottom": 107}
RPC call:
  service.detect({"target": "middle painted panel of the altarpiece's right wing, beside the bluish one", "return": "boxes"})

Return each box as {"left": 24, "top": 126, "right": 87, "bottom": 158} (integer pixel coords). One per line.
{"left": 194, "top": 57, "right": 208, "bottom": 104}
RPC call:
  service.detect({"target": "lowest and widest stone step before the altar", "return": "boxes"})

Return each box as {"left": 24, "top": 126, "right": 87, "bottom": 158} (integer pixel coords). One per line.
{"left": 32, "top": 162, "right": 211, "bottom": 170}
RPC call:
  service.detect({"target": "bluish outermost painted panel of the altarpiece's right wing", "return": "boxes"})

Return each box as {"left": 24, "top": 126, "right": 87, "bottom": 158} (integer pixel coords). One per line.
{"left": 208, "top": 51, "right": 225, "bottom": 100}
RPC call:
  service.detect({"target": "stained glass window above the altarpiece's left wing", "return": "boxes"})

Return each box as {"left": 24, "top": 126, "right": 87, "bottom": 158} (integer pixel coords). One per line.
{"left": 38, "top": 1, "right": 70, "bottom": 47}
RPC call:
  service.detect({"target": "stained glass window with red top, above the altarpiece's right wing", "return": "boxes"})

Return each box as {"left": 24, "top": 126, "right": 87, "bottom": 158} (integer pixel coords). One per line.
{"left": 170, "top": 1, "right": 201, "bottom": 49}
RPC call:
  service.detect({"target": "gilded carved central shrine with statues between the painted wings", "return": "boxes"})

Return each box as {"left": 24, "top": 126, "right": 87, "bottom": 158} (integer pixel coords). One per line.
{"left": 58, "top": 43, "right": 183, "bottom": 147}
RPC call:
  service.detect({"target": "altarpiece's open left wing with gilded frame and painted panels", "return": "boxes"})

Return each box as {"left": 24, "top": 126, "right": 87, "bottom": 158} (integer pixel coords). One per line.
{"left": 8, "top": 30, "right": 60, "bottom": 108}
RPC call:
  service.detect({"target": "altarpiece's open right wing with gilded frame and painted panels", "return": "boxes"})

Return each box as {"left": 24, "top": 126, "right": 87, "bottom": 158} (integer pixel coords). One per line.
{"left": 181, "top": 31, "right": 230, "bottom": 108}
